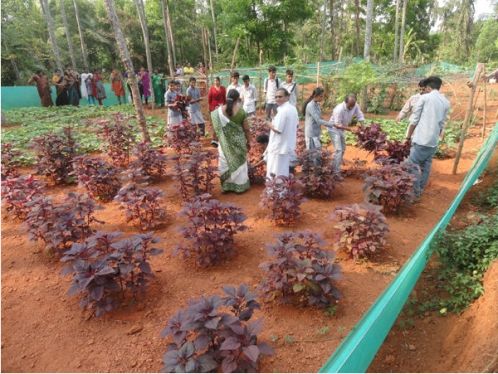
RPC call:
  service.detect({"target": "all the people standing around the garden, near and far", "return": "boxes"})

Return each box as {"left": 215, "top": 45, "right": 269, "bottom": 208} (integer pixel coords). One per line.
{"left": 30, "top": 64, "right": 450, "bottom": 200}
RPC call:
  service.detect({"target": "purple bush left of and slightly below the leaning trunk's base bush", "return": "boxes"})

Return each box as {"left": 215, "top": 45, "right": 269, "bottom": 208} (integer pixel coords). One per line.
{"left": 73, "top": 156, "right": 121, "bottom": 202}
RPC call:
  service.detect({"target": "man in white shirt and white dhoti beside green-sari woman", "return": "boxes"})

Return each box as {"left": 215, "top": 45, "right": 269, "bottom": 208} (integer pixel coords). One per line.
{"left": 265, "top": 88, "right": 299, "bottom": 178}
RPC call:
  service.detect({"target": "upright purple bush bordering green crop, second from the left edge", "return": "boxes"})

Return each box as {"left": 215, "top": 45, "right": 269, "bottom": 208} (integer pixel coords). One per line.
{"left": 32, "top": 127, "right": 76, "bottom": 184}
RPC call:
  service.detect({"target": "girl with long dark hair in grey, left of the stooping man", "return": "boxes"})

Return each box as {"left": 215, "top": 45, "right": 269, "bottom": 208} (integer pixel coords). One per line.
{"left": 303, "top": 87, "right": 332, "bottom": 150}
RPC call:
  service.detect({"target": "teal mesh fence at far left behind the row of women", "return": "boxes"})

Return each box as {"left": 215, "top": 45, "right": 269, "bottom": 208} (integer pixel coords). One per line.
{"left": 1, "top": 83, "right": 126, "bottom": 110}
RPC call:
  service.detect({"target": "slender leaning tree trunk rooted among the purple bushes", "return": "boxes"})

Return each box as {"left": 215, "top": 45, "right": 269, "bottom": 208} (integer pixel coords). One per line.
{"left": 104, "top": 0, "right": 150, "bottom": 142}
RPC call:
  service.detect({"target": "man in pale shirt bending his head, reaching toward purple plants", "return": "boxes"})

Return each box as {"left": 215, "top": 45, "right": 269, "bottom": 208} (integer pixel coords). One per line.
{"left": 329, "top": 94, "right": 365, "bottom": 177}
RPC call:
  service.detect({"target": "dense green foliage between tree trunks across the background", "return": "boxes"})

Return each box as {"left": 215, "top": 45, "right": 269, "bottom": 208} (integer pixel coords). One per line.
{"left": 1, "top": 0, "right": 498, "bottom": 85}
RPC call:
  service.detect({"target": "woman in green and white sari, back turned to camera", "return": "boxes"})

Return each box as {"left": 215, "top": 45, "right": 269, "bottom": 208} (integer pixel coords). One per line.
{"left": 211, "top": 90, "right": 250, "bottom": 193}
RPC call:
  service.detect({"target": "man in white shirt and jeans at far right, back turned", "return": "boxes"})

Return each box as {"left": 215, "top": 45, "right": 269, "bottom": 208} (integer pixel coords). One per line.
{"left": 406, "top": 76, "right": 450, "bottom": 197}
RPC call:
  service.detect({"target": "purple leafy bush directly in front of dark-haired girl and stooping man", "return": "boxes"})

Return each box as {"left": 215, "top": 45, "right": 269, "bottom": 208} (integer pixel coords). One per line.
{"left": 299, "top": 149, "right": 337, "bottom": 198}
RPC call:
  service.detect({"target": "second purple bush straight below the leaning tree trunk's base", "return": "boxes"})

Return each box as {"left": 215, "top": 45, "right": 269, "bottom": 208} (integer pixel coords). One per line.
{"left": 114, "top": 183, "right": 166, "bottom": 230}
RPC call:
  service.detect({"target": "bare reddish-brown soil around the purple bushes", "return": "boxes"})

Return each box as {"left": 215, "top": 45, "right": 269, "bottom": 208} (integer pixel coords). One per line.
{"left": 2, "top": 104, "right": 480, "bottom": 372}
